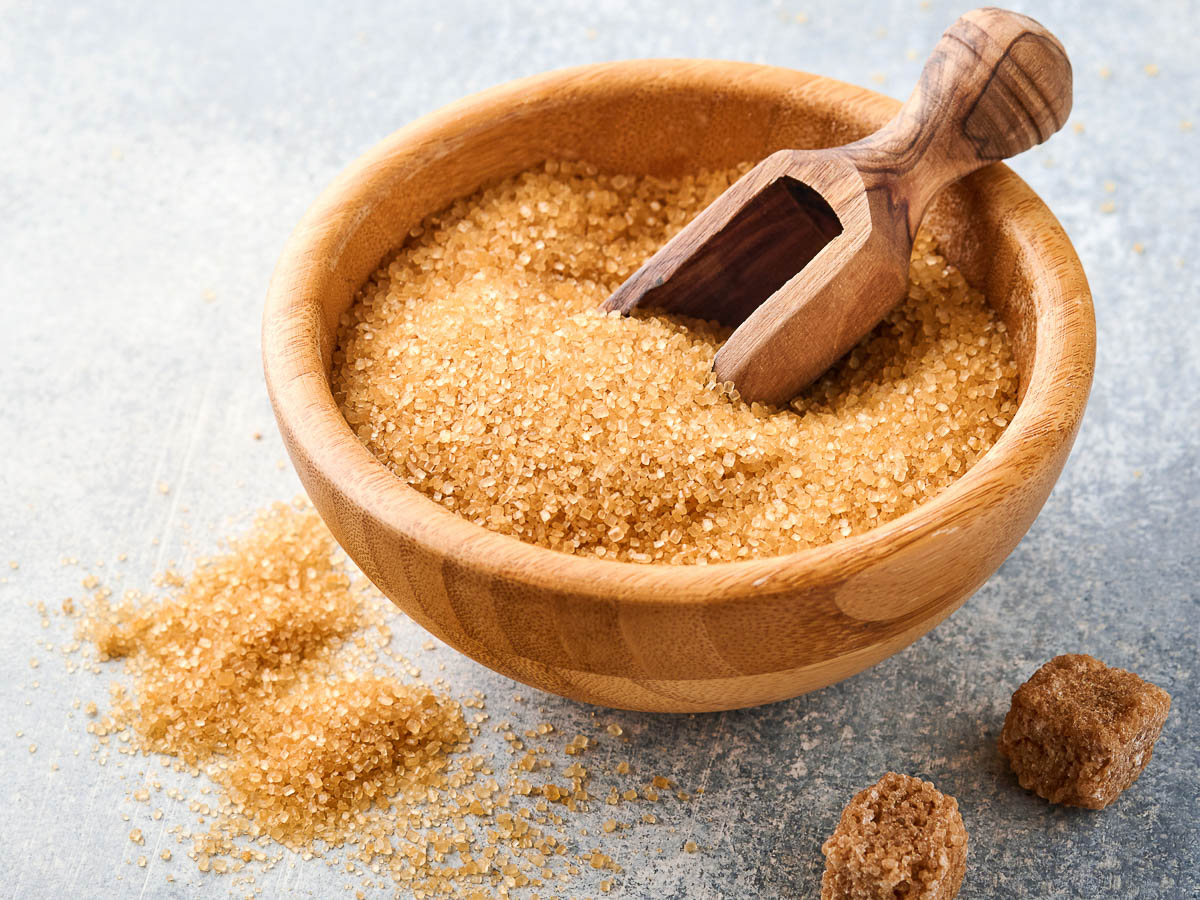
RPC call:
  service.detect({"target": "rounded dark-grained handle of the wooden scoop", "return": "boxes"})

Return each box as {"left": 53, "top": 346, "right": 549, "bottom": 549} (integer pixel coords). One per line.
{"left": 845, "top": 7, "right": 1072, "bottom": 234}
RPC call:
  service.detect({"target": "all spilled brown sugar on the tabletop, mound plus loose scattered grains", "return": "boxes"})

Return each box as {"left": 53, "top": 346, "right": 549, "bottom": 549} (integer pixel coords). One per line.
{"left": 71, "top": 504, "right": 696, "bottom": 898}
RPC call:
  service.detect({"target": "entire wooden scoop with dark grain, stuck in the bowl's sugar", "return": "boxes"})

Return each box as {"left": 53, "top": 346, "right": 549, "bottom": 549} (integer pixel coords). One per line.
{"left": 604, "top": 8, "right": 1072, "bottom": 404}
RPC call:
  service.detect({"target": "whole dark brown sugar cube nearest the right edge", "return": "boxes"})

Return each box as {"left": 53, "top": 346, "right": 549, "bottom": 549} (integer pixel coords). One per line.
{"left": 1000, "top": 654, "right": 1171, "bottom": 809}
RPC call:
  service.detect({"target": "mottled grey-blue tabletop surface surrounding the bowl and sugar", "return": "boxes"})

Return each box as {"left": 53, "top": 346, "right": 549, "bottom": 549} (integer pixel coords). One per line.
{"left": 0, "top": 0, "right": 1200, "bottom": 898}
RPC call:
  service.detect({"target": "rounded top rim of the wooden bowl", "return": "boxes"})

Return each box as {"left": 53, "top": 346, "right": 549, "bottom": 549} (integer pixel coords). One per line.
{"left": 263, "top": 59, "right": 1096, "bottom": 604}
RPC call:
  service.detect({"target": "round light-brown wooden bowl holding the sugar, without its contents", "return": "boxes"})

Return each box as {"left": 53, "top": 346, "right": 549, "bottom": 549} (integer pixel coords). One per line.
{"left": 263, "top": 60, "right": 1096, "bottom": 712}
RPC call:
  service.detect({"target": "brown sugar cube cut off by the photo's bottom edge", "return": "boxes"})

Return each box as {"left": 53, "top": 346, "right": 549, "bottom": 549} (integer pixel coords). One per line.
{"left": 821, "top": 772, "right": 967, "bottom": 900}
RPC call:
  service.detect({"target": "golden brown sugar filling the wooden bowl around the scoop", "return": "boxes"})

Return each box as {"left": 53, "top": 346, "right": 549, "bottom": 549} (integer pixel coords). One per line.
{"left": 332, "top": 162, "right": 1018, "bottom": 564}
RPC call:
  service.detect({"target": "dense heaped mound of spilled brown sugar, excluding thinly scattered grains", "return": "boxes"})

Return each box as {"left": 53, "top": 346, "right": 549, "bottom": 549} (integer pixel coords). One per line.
{"left": 86, "top": 504, "right": 468, "bottom": 846}
